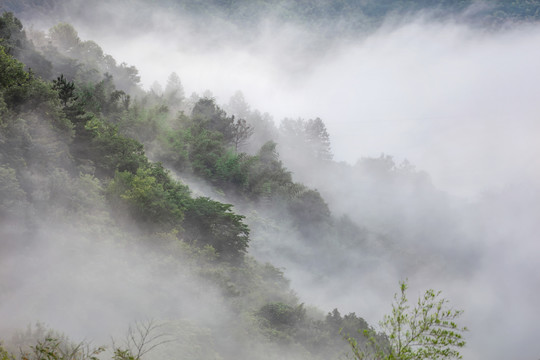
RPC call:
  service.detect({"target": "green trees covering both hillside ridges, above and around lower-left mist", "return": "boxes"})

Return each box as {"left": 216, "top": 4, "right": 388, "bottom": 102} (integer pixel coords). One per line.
{"left": 0, "top": 13, "right": 388, "bottom": 359}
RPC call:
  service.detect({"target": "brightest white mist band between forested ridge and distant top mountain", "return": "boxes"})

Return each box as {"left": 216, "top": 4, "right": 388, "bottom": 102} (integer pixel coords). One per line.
{"left": 57, "top": 15, "right": 540, "bottom": 200}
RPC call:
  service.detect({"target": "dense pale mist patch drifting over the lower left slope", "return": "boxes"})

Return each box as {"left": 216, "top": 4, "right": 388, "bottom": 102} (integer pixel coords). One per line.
{"left": 0, "top": 223, "right": 228, "bottom": 345}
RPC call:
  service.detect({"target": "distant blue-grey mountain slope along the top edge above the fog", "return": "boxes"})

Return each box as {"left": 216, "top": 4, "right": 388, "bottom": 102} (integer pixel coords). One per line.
{"left": 0, "top": 0, "right": 540, "bottom": 33}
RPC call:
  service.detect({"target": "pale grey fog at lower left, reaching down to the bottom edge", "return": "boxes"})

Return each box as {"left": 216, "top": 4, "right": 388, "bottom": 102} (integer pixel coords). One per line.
{"left": 0, "top": 219, "right": 308, "bottom": 360}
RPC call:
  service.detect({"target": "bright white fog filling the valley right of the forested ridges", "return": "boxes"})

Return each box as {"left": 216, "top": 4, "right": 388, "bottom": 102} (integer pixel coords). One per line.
{"left": 9, "top": 2, "right": 540, "bottom": 360}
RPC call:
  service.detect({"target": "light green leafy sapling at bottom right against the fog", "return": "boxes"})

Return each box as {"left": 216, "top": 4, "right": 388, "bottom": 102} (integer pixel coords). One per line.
{"left": 346, "top": 282, "right": 467, "bottom": 360}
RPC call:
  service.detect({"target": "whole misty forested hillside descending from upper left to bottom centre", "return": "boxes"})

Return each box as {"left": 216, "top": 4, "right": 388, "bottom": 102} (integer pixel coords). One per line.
{"left": 0, "top": 13, "right": 392, "bottom": 359}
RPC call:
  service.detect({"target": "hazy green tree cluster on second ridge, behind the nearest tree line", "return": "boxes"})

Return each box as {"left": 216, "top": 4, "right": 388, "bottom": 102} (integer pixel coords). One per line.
{"left": 153, "top": 98, "right": 331, "bottom": 236}
